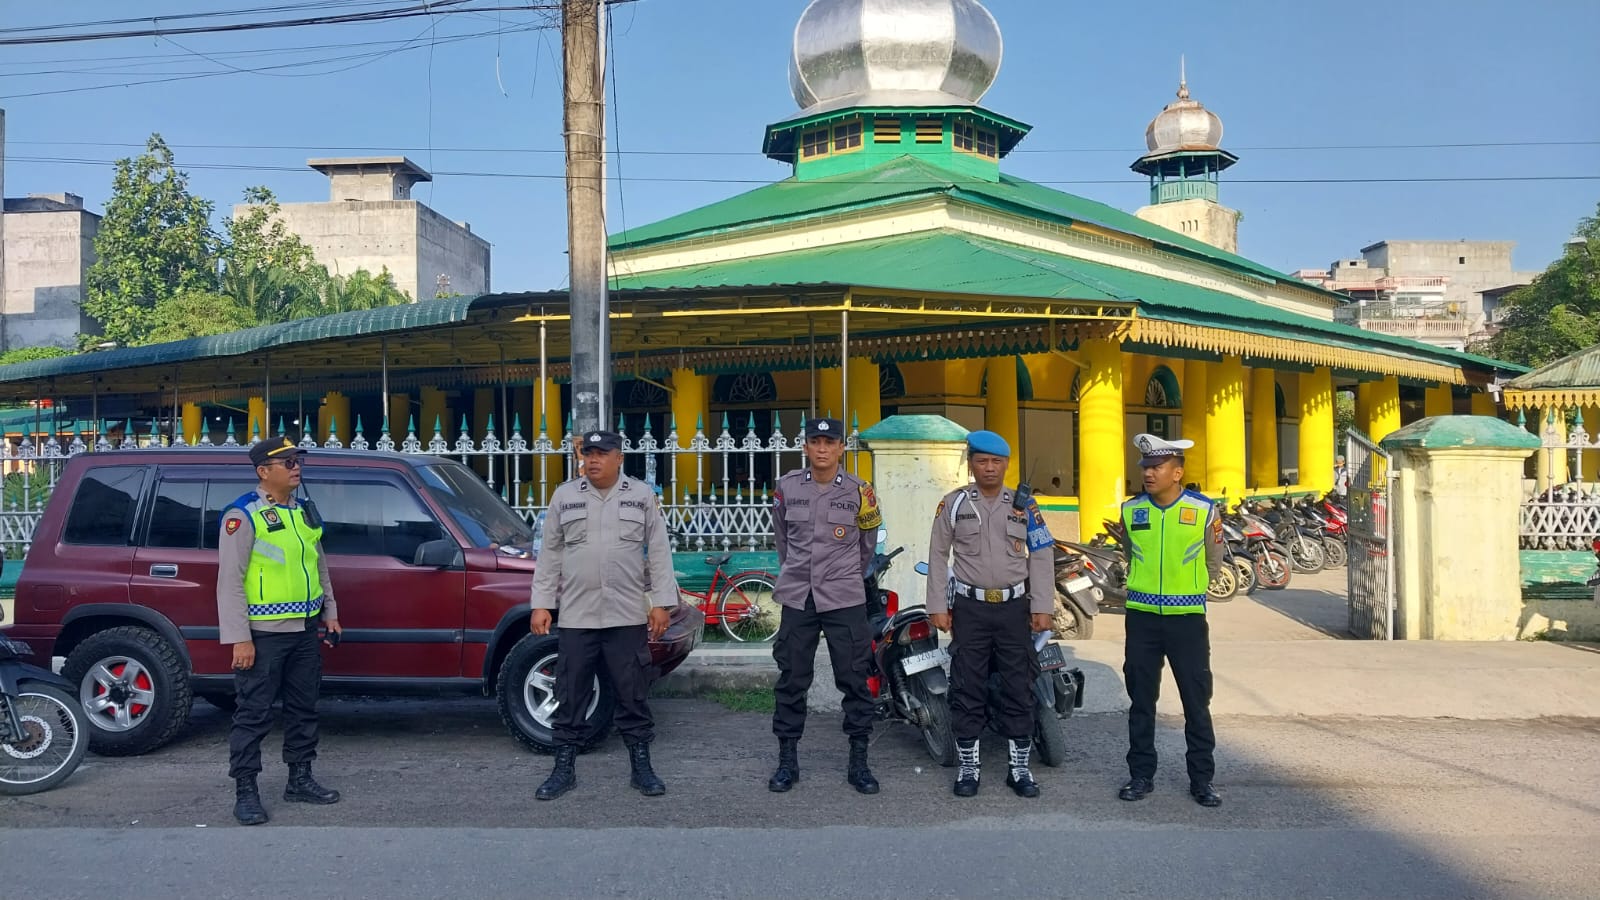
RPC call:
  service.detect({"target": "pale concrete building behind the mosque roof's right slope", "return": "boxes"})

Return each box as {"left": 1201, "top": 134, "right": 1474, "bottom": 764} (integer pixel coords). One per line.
{"left": 1294, "top": 240, "right": 1539, "bottom": 351}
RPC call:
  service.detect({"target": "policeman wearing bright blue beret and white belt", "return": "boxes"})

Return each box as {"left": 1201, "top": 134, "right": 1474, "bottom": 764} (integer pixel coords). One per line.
{"left": 928, "top": 431, "right": 1056, "bottom": 798}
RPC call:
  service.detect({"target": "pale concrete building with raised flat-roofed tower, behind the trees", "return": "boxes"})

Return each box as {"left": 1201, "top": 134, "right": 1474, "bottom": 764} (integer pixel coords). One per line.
{"left": 243, "top": 157, "right": 490, "bottom": 299}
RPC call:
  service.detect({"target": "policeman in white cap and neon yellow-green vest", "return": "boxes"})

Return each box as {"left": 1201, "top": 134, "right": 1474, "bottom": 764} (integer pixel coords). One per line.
{"left": 1117, "top": 434, "right": 1226, "bottom": 807}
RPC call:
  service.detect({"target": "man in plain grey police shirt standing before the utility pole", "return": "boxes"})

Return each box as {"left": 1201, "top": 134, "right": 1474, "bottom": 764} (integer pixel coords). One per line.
{"left": 530, "top": 431, "right": 678, "bottom": 801}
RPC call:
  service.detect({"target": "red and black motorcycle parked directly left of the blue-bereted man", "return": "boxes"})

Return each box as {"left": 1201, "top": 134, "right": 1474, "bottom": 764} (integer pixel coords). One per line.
{"left": 864, "top": 548, "right": 955, "bottom": 765}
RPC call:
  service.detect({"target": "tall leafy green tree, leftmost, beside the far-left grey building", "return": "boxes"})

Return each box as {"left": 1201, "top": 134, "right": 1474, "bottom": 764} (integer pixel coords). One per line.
{"left": 82, "top": 135, "right": 221, "bottom": 346}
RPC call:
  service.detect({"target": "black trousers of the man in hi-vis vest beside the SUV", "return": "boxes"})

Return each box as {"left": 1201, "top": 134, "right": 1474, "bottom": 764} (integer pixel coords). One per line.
{"left": 227, "top": 618, "right": 322, "bottom": 778}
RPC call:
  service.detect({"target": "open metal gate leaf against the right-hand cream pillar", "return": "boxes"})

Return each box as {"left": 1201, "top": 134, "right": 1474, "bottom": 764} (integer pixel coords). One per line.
{"left": 1344, "top": 429, "right": 1395, "bottom": 641}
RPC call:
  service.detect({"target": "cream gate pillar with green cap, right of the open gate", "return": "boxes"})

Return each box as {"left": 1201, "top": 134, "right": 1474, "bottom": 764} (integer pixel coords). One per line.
{"left": 1381, "top": 416, "right": 1539, "bottom": 641}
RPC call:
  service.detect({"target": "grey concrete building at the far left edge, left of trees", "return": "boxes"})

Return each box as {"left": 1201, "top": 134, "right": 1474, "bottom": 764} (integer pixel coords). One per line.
{"left": 0, "top": 110, "right": 101, "bottom": 351}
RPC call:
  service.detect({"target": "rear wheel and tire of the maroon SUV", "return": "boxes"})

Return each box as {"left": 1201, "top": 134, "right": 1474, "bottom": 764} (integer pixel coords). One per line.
{"left": 61, "top": 625, "right": 194, "bottom": 756}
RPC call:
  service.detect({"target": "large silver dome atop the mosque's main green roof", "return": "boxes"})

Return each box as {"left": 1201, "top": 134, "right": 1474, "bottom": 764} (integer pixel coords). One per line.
{"left": 789, "top": 0, "right": 1002, "bottom": 112}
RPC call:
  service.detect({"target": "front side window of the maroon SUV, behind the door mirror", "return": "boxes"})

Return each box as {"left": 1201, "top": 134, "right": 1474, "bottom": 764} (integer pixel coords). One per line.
{"left": 307, "top": 472, "right": 446, "bottom": 564}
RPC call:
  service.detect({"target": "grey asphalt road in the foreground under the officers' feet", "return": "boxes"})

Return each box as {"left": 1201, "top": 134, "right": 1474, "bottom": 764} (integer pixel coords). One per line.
{"left": 0, "top": 700, "right": 1600, "bottom": 898}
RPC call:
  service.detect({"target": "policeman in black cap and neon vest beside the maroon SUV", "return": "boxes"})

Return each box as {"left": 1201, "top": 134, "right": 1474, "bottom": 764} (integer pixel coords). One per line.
{"left": 216, "top": 437, "right": 344, "bottom": 825}
